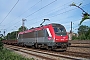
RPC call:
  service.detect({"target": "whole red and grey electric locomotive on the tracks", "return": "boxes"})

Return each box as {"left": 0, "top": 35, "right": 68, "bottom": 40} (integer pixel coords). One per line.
{"left": 17, "top": 23, "right": 68, "bottom": 50}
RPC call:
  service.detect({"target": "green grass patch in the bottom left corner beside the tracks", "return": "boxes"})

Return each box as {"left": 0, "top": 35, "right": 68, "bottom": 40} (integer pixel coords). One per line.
{"left": 0, "top": 48, "right": 34, "bottom": 60}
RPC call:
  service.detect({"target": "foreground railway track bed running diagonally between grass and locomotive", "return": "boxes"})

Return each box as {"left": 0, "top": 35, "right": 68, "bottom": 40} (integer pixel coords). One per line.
{"left": 6, "top": 45, "right": 90, "bottom": 60}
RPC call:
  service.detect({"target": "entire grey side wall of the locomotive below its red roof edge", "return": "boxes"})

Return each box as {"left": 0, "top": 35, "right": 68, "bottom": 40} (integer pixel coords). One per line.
{"left": 18, "top": 29, "right": 53, "bottom": 46}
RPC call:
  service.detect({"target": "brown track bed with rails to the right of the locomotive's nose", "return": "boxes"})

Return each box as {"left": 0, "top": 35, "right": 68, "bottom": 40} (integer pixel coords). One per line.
{"left": 67, "top": 40, "right": 90, "bottom": 54}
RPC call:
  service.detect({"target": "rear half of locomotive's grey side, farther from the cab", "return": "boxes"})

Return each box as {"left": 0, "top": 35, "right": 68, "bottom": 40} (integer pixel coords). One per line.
{"left": 18, "top": 32, "right": 36, "bottom": 46}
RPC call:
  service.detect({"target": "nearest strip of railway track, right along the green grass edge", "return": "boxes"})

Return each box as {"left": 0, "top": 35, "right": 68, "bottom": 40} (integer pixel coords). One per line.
{"left": 5, "top": 45, "right": 55, "bottom": 60}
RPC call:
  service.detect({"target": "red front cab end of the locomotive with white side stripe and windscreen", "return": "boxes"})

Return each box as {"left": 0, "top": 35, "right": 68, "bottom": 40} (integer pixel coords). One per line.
{"left": 47, "top": 24, "right": 68, "bottom": 49}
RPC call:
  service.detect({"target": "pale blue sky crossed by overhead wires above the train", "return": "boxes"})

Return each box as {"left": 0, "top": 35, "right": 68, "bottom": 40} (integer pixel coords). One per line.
{"left": 0, "top": 0, "right": 90, "bottom": 33}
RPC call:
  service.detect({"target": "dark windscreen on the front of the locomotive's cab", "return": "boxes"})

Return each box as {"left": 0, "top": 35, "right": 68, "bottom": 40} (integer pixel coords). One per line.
{"left": 53, "top": 24, "right": 67, "bottom": 36}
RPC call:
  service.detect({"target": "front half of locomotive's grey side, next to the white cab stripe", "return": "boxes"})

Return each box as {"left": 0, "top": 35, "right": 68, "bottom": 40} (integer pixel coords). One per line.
{"left": 37, "top": 29, "right": 53, "bottom": 46}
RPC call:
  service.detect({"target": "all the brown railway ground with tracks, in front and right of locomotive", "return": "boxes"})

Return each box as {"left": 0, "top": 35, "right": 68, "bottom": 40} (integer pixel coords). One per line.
{"left": 1, "top": 40, "right": 90, "bottom": 60}
